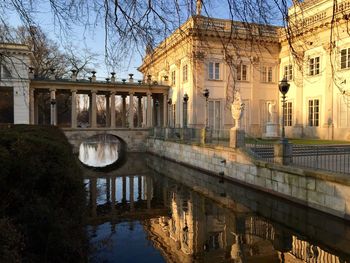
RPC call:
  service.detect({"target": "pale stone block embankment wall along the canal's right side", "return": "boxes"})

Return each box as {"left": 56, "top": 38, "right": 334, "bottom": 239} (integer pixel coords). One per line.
{"left": 147, "top": 138, "right": 350, "bottom": 220}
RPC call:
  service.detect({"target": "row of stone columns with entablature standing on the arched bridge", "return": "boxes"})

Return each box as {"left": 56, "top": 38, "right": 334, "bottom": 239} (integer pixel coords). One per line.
{"left": 29, "top": 76, "right": 169, "bottom": 129}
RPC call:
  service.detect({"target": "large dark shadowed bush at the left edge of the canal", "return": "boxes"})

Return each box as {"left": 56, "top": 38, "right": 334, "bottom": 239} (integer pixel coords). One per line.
{"left": 0, "top": 125, "right": 86, "bottom": 262}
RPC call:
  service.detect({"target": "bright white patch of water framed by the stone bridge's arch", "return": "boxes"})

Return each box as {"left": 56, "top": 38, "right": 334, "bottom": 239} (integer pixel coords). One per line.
{"left": 79, "top": 134, "right": 121, "bottom": 167}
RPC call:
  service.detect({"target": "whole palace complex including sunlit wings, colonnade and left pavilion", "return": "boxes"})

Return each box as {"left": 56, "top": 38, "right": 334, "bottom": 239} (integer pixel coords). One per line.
{"left": 0, "top": 0, "right": 350, "bottom": 140}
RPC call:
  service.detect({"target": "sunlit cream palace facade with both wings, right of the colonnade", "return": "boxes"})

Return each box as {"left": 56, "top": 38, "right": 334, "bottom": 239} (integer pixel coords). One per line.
{"left": 139, "top": 0, "right": 350, "bottom": 140}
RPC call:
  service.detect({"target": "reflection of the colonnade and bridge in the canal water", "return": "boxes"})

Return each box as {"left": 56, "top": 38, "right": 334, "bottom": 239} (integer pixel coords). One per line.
{"left": 86, "top": 174, "right": 168, "bottom": 224}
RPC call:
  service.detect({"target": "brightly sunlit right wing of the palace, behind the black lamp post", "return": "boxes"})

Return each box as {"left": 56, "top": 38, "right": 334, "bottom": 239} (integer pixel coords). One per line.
{"left": 280, "top": 0, "right": 350, "bottom": 140}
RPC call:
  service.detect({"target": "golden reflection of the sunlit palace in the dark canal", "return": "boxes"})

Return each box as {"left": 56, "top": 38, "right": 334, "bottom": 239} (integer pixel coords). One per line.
{"left": 143, "top": 179, "right": 346, "bottom": 263}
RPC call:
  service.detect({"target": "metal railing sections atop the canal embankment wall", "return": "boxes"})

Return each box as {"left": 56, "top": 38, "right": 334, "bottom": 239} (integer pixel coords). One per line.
{"left": 151, "top": 128, "right": 350, "bottom": 174}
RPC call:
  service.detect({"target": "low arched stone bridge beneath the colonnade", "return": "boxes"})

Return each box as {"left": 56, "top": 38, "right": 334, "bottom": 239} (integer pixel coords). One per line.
{"left": 62, "top": 128, "right": 149, "bottom": 153}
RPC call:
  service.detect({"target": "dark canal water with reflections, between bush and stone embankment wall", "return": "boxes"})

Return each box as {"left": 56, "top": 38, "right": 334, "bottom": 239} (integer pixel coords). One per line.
{"left": 84, "top": 154, "right": 350, "bottom": 263}
